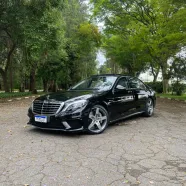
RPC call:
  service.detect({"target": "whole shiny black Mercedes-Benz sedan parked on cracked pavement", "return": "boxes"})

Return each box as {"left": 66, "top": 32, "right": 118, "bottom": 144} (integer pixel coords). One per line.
{"left": 28, "top": 74, "right": 156, "bottom": 134}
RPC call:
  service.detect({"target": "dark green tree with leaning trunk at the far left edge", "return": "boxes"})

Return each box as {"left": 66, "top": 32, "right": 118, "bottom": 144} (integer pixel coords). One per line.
{"left": 0, "top": 0, "right": 23, "bottom": 92}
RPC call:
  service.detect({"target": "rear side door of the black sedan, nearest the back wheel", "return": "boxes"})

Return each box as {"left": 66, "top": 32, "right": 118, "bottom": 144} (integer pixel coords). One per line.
{"left": 128, "top": 78, "right": 148, "bottom": 112}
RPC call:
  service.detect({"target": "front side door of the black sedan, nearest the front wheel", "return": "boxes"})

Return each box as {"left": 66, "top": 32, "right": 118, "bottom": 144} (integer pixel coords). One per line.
{"left": 110, "top": 77, "right": 135, "bottom": 120}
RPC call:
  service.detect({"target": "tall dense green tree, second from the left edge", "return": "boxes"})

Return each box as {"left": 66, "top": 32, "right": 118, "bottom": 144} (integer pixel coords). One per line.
{"left": 22, "top": 1, "right": 65, "bottom": 91}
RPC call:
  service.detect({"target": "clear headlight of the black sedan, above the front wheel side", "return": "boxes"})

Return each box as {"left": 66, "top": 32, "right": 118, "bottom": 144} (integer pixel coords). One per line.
{"left": 62, "top": 100, "right": 88, "bottom": 112}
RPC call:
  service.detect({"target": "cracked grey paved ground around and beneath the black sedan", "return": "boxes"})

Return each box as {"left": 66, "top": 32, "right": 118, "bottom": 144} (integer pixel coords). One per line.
{"left": 0, "top": 99, "right": 186, "bottom": 186}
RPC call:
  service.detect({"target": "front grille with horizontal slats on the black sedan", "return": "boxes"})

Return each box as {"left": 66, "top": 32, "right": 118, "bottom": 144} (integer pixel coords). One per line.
{"left": 33, "top": 100, "right": 64, "bottom": 115}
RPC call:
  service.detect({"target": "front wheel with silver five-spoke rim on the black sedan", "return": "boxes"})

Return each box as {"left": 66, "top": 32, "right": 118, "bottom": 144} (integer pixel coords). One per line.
{"left": 87, "top": 105, "right": 109, "bottom": 134}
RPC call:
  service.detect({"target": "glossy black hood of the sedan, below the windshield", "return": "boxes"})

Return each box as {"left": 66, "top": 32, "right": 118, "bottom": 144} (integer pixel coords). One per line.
{"left": 36, "top": 91, "right": 105, "bottom": 102}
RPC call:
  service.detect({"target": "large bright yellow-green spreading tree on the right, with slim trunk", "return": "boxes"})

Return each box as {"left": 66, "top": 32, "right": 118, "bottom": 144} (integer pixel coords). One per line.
{"left": 92, "top": 0, "right": 186, "bottom": 92}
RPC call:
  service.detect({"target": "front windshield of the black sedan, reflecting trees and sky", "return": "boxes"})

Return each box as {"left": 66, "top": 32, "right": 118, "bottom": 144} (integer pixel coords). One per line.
{"left": 71, "top": 76, "right": 117, "bottom": 90}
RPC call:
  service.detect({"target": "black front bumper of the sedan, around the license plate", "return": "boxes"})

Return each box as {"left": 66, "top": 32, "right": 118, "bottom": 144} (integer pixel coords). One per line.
{"left": 28, "top": 109, "right": 88, "bottom": 132}
